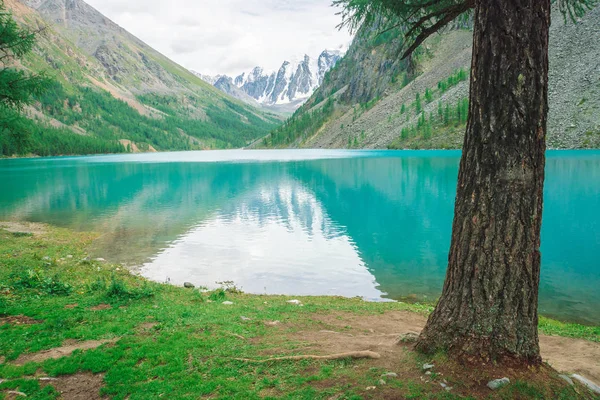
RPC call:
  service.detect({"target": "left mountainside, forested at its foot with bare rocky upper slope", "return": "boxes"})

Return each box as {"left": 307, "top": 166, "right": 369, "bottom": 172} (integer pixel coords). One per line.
{"left": 0, "top": 0, "right": 280, "bottom": 156}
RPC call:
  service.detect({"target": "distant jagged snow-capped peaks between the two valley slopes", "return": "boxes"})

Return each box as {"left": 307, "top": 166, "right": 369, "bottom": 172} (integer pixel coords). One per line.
{"left": 196, "top": 50, "right": 343, "bottom": 107}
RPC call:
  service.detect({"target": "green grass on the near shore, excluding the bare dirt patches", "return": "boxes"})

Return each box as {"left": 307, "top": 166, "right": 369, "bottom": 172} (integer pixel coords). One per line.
{"left": 0, "top": 227, "right": 600, "bottom": 400}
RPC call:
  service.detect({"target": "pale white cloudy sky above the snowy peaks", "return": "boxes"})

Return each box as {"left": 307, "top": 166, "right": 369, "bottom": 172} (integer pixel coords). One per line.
{"left": 87, "top": 0, "right": 351, "bottom": 75}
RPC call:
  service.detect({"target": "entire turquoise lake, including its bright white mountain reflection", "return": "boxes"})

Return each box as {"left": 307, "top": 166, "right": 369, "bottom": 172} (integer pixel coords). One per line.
{"left": 0, "top": 150, "right": 600, "bottom": 324}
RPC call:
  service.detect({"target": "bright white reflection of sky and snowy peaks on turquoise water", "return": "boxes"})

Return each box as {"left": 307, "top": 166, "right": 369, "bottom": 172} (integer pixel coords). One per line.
{"left": 142, "top": 179, "right": 381, "bottom": 299}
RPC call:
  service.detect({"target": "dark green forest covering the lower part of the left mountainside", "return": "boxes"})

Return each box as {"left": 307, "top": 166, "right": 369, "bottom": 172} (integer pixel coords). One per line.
{"left": 0, "top": 81, "right": 277, "bottom": 156}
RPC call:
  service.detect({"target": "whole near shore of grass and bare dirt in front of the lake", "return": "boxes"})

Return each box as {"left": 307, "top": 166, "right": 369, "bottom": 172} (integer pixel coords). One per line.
{"left": 0, "top": 227, "right": 600, "bottom": 400}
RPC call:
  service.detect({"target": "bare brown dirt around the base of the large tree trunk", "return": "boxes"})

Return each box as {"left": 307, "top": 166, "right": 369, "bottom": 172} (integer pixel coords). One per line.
{"left": 278, "top": 311, "right": 600, "bottom": 395}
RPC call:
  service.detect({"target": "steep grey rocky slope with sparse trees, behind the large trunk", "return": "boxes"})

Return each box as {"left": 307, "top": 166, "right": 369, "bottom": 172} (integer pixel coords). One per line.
{"left": 266, "top": 6, "right": 600, "bottom": 148}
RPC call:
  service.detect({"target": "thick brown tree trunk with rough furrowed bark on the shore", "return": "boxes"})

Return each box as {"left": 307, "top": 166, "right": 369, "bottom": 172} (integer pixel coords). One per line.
{"left": 417, "top": 0, "right": 550, "bottom": 364}
